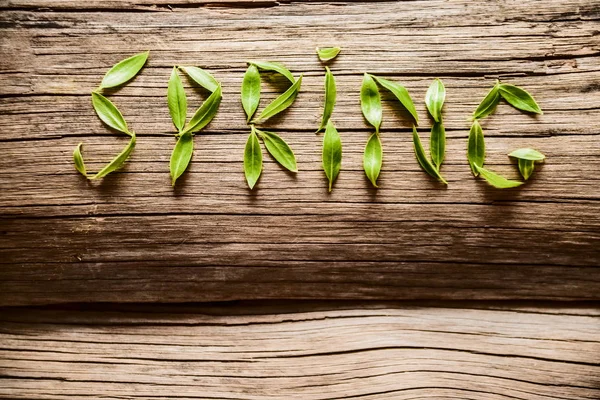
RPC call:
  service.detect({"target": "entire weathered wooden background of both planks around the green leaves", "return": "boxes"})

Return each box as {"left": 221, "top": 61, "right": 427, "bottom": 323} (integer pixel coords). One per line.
{"left": 0, "top": 0, "right": 600, "bottom": 399}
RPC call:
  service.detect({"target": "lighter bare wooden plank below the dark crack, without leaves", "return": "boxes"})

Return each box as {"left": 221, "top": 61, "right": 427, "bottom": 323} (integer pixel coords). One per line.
{"left": 0, "top": 304, "right": 600, "bottom": 400}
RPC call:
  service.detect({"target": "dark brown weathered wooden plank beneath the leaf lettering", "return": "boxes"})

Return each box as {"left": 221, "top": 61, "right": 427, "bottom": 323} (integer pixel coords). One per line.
{"left": 0, "top": 0, "right": 600, "bottom": 305}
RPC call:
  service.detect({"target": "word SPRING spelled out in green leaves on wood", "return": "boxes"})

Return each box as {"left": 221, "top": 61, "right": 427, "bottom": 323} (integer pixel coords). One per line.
{"left": 73, "top": 47, "right": 545, "bottom": 191}
